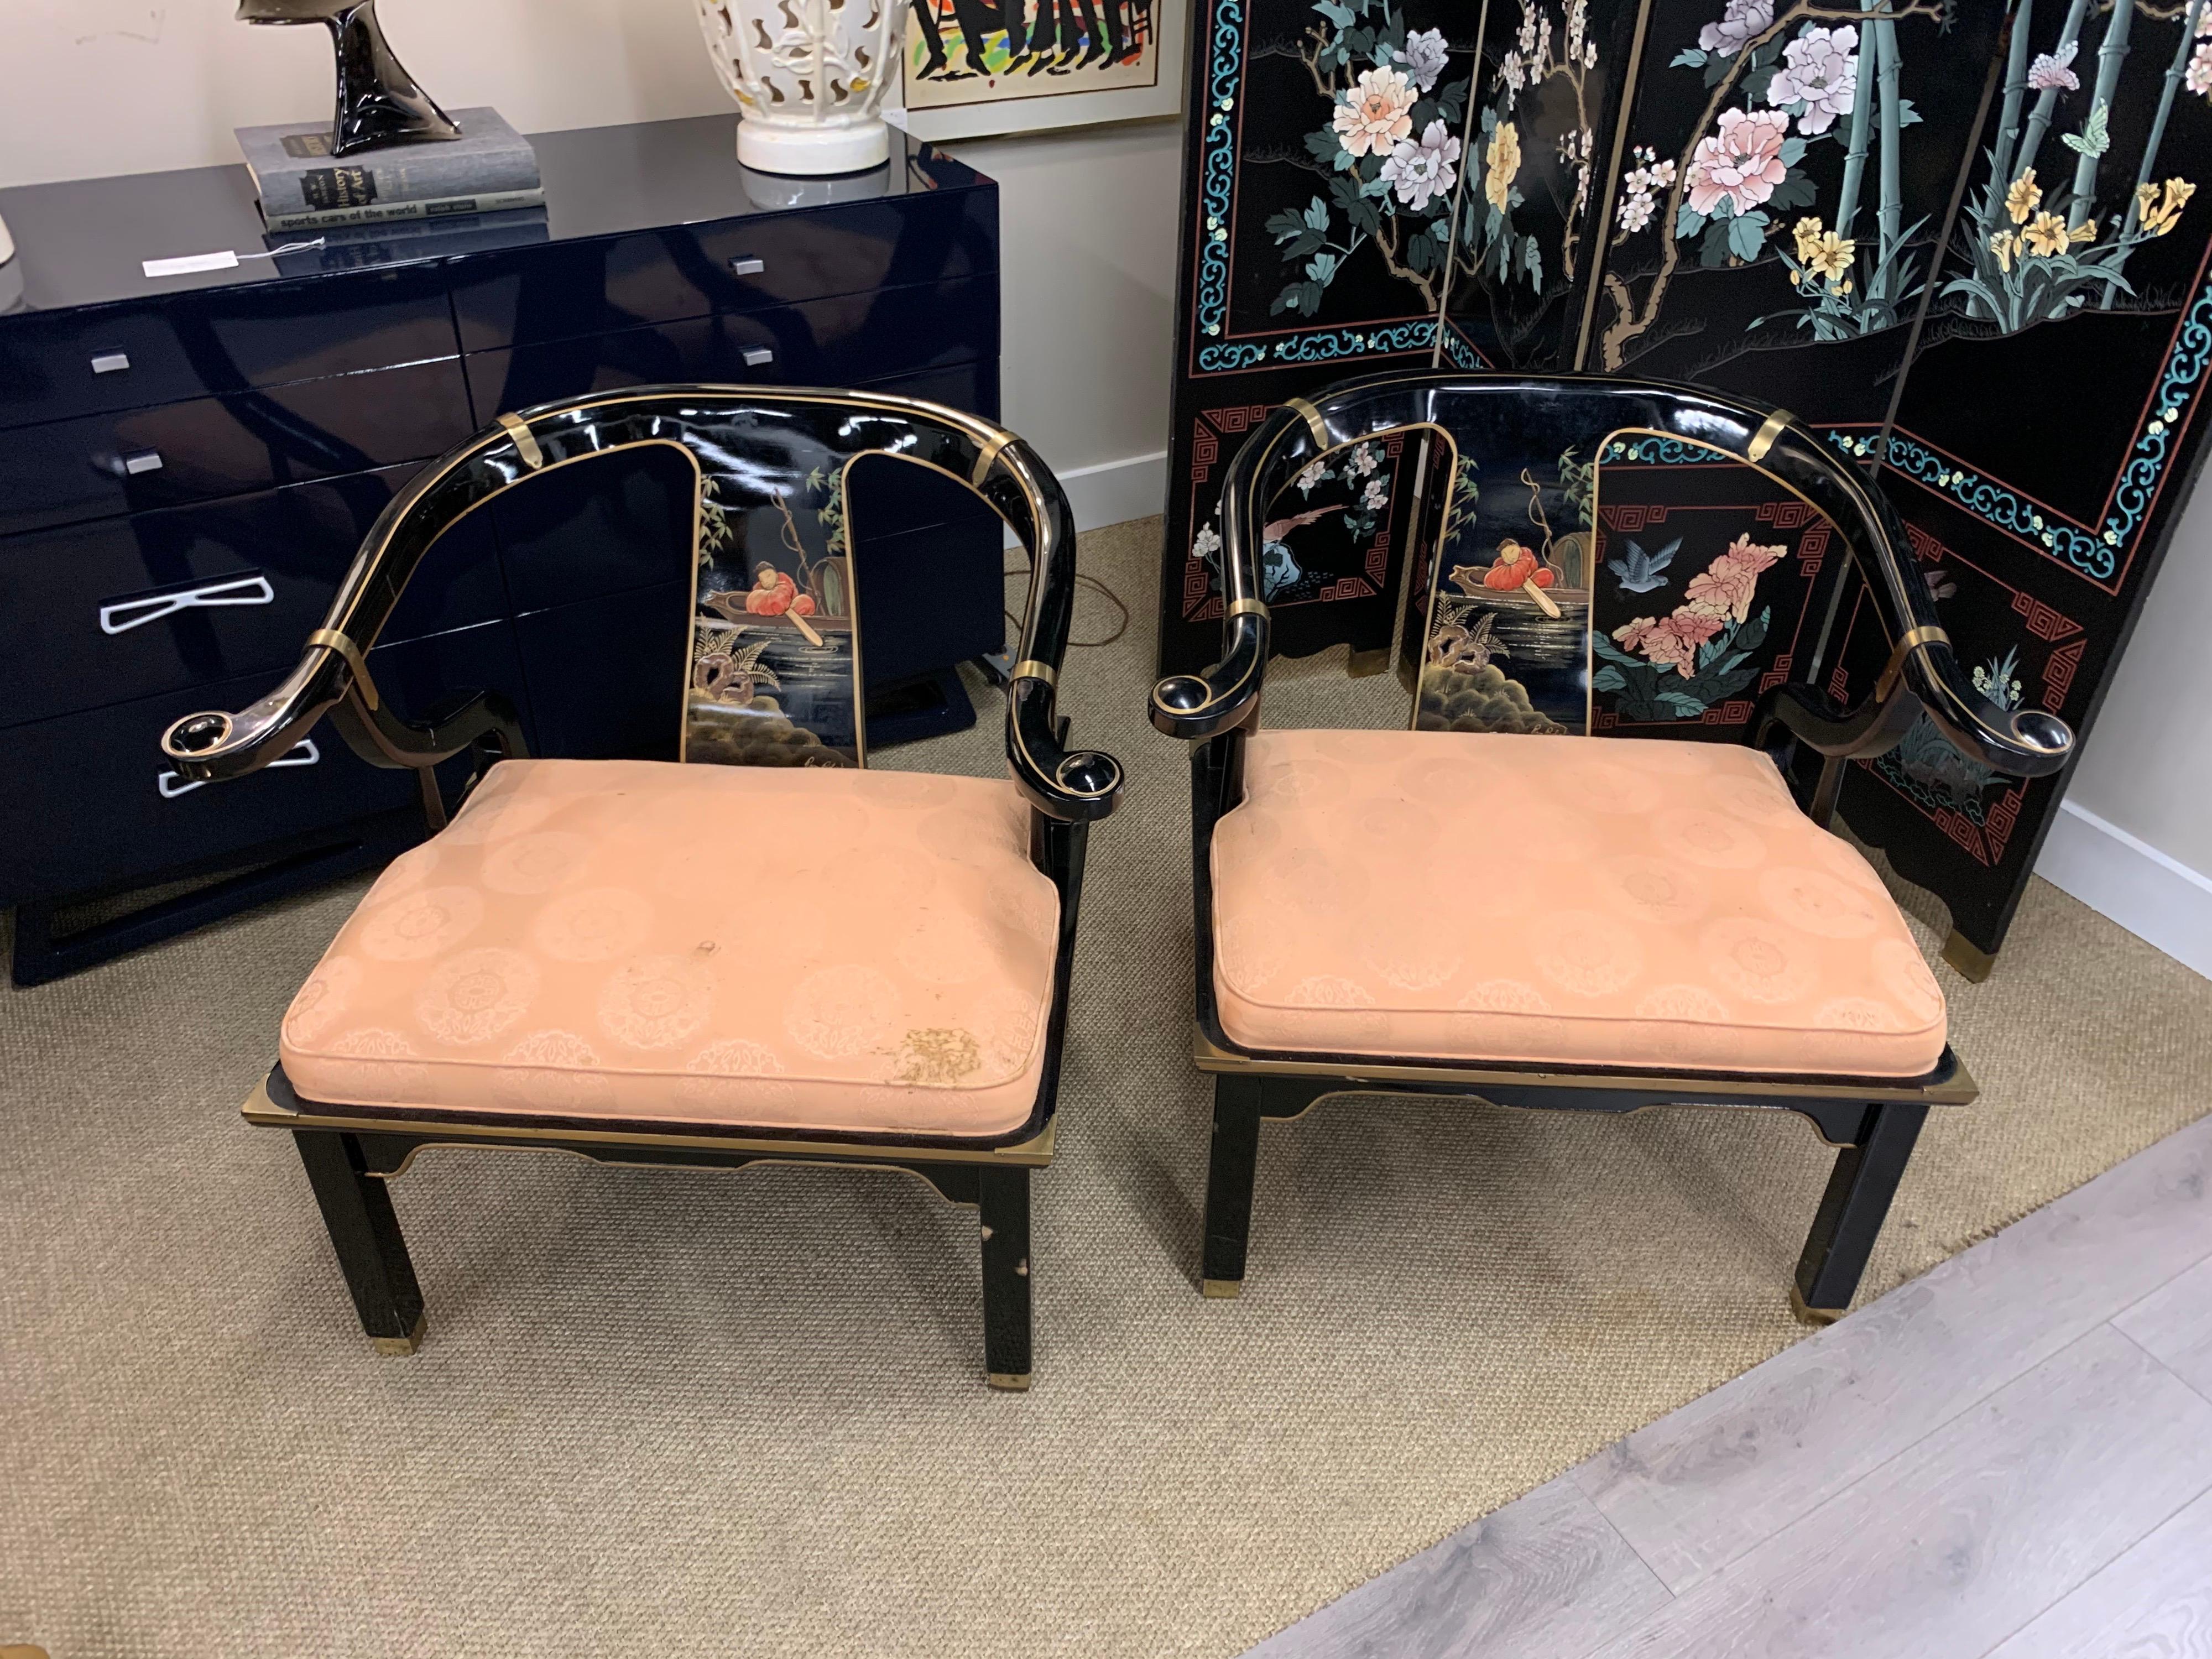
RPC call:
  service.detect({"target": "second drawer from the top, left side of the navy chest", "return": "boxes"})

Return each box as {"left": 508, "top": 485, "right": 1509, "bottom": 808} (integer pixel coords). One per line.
{"left": 0, "top": 358, "right": 473, "bottom": 535}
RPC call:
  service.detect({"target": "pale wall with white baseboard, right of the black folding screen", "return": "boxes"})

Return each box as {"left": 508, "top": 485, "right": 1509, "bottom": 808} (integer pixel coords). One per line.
{"left": 2035, "top": 489, "right": 2212, "bottom": 978}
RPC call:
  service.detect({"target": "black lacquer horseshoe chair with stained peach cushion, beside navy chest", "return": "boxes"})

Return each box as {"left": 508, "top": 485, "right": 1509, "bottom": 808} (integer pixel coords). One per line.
{"left": 161, "top": 387, "right": 1121, "bottom": 1389}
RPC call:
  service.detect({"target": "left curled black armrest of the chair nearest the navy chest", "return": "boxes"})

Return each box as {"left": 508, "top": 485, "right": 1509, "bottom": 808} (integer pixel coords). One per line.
{"left": 161, "top": 628, "right": 526, "bottom": 783}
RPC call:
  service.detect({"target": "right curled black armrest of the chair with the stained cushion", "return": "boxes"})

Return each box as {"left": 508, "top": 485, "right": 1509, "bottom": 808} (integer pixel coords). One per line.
{"left": 978, "top": 434, "right": 1121, "bottom": 823}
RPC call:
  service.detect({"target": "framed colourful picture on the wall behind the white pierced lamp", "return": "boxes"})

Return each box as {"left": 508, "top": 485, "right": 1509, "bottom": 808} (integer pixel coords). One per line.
{"left": 907, "top": 0, "right": 1161, "bottom": 108}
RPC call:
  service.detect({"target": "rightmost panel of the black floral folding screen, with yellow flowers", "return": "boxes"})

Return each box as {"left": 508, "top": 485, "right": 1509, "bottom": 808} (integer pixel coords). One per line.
{"left": 1834, "top": 0, "right": 2212, "bottom": 951}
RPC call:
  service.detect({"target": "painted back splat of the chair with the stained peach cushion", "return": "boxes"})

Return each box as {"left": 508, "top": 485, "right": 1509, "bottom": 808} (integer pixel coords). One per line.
{"left": 684, "top": 469, "right": 865, "bottom": 765}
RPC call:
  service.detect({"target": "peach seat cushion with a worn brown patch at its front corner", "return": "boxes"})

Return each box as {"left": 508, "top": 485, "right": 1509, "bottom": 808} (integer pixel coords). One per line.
{"left": 281, "top": 761, "right": 1060, "bottom": 1137}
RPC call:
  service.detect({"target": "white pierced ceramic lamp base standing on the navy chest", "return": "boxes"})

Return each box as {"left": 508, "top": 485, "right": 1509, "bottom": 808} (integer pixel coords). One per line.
{"left": 697, "top": 0, "right": 907, "bottom": 177}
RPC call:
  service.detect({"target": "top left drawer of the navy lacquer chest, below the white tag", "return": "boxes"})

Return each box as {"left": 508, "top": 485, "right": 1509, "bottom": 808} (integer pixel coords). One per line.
{"left": 0, "top": 265, "right": 458, "bottom": 427}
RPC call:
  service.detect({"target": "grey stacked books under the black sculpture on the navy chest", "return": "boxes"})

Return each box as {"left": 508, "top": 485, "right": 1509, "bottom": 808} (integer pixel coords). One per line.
{"left": 239, "top": 108, "right": 546, "bottom": 230}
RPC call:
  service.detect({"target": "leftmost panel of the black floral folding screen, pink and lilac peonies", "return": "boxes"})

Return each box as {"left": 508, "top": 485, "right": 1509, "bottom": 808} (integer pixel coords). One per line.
{"left": 1159, "top": 0, "right": 1482, "bottom": 668}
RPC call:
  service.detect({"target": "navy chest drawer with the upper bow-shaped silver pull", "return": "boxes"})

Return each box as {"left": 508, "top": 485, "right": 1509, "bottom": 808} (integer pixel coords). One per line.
{"left": 0, "top": 467, "right": 507, "bottom": 726}
